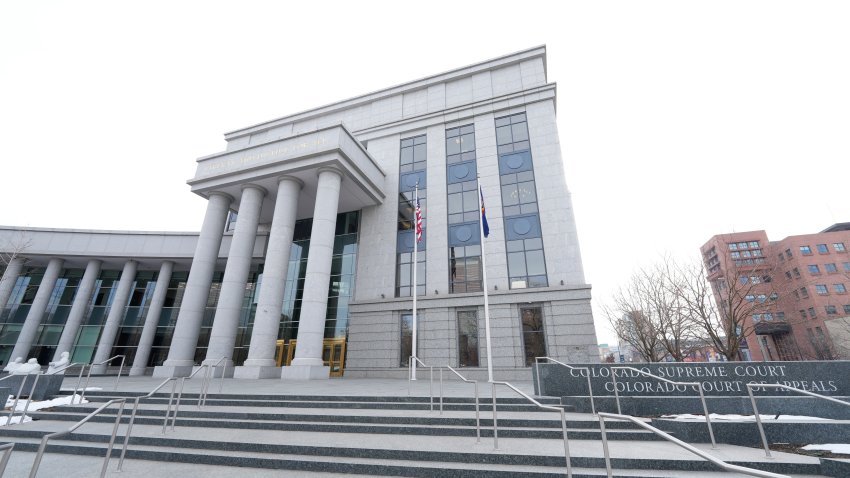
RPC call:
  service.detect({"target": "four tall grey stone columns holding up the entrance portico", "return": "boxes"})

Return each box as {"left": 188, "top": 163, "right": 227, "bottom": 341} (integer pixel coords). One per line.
{"left": 154, "top": 168, "right": 342, "bottom": 379}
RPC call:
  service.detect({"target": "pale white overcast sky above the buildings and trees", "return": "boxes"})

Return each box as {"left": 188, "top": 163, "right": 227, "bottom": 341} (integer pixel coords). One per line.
{"left": 0, "top": 0, "right": 850, "bottom": 342}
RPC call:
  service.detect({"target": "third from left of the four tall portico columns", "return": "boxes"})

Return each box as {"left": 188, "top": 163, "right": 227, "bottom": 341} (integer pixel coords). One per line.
{"left": 234, "top": 176, "right": 304, "bottom": 378}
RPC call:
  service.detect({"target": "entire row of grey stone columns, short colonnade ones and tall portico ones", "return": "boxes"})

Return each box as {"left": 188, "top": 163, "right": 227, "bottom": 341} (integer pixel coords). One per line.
{"left": 0, "top": 168, "right": 342, "bottom": 379}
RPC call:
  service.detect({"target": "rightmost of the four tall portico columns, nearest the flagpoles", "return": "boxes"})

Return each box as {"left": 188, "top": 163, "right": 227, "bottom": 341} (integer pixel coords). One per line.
{"left": 281, "top": 168, "right": 342, "bottom": 380}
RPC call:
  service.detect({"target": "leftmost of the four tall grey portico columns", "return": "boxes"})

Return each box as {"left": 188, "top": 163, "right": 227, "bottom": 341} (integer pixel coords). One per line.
{"left": 153, "top": 193, "right": 232, "bottom": 377}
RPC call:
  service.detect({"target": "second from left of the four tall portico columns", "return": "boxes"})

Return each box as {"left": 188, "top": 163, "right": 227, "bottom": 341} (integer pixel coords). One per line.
{"left": 204, "top": 184, "right": 266, "bottom": 371}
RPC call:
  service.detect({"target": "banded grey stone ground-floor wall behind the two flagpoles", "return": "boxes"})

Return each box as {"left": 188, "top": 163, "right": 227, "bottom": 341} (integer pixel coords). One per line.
{"left": 345, "top": 287, "right": 596, "bottom": 380}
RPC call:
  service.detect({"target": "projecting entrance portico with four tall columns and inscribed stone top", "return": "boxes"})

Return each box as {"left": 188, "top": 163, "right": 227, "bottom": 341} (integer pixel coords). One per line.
{"left": 154, "top": 125, "right": 385, "bottom": 379}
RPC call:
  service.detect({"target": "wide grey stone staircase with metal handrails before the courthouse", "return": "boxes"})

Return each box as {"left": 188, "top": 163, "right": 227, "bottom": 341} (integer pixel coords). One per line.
{"left": 0, "top": 381, "right": 824, "bottom": 478}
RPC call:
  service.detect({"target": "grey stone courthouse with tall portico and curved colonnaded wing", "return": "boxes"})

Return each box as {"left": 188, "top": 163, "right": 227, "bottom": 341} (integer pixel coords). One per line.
{"left": 0, "top": 47, "right": 596, "bottom": 379}
